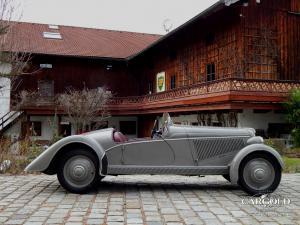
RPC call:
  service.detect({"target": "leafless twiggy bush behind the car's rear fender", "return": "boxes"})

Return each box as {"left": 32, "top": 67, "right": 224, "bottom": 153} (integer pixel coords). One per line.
{"left": 57, "top": 88, "right": 112, "bottom": 133}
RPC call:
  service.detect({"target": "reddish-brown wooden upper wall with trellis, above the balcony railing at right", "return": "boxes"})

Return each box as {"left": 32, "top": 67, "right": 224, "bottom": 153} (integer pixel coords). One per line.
{"left": 132, "top": 0, "right": 300, "bottom": 94}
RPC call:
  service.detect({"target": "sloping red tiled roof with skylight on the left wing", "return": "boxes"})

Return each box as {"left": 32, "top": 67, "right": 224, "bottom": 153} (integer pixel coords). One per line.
{"left": 3, "top": 22, "right": 161, "bottom": 59}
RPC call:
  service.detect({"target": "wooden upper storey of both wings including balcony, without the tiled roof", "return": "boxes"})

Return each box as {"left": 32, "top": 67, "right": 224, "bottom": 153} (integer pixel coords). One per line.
{"left": 10, "top": 0, "right": 300, "bottom": 136}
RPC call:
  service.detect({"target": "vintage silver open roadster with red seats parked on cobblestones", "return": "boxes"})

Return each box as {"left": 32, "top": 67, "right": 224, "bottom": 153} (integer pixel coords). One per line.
{"left": 25, "top": 114, "right": 283, "bottom": 195}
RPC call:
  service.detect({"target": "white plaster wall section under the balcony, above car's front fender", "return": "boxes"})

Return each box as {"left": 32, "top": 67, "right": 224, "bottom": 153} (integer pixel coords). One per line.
{"left": 238, "top": 109, "right": 286, "bottom": 131}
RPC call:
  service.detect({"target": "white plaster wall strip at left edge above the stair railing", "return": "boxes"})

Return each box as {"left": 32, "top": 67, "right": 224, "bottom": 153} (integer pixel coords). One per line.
{"left": 0, "top": 78, "right": 10, "bottom": 117}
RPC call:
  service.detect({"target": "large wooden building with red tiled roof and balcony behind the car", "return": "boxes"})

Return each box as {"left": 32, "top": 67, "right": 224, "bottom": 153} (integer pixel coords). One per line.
{"left": 0, "top": 0, "right": 300, "bottom": 141}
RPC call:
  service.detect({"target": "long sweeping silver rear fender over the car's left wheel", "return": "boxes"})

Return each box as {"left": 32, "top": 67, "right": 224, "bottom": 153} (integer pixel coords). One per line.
{"left": 25, "top": 135, "right": 105, "bottom": 174}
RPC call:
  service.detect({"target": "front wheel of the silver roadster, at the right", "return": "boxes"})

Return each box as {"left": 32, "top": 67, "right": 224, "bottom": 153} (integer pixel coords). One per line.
{"left": 238, "top": 153, "right": 281, "bottom": 195}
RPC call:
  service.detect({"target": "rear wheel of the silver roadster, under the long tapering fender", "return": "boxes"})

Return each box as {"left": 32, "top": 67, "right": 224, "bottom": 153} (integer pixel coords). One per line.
{"left": 57, "top": 149, "right": 100, "bottom": 194}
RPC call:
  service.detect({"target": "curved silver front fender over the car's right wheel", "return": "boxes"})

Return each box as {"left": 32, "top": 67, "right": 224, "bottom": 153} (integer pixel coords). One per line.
{"left": 229, "top": 144, "right": 284, "bottom": 184}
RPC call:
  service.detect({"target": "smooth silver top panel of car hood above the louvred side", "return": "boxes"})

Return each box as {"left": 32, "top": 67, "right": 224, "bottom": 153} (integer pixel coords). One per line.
{"left": 163, "top": 125, "right": 255, "bottom": 138}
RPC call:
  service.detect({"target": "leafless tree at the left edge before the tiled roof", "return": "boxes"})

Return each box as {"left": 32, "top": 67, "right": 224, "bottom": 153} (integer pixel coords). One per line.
{"left": 0, "top": 0, "right": 30, "bottom": 91}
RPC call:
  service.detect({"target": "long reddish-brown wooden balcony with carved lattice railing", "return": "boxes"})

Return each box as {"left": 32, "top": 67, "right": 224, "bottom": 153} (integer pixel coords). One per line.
{"left": 23, "top": 79, "right": 300, "bottom": 115}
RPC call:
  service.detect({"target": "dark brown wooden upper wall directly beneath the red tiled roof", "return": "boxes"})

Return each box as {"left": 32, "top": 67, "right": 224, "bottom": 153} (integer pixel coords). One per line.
{"left": 16, "top": 55, "right": 138, "bottom": 96}
